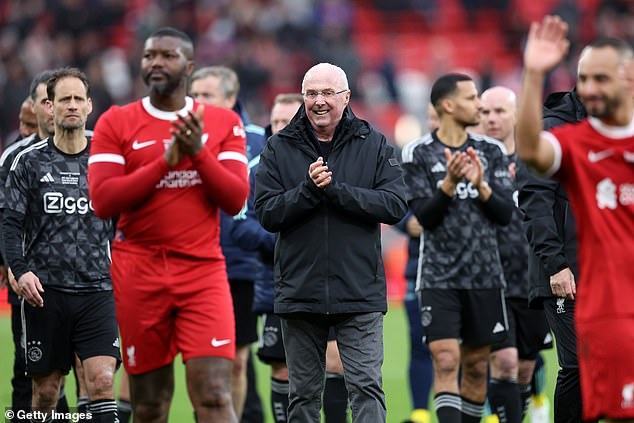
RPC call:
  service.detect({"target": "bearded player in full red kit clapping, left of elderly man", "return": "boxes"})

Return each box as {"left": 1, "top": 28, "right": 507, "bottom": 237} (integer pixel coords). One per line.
{"left": 89, "top": 28, "right": 248, "bottom": 422}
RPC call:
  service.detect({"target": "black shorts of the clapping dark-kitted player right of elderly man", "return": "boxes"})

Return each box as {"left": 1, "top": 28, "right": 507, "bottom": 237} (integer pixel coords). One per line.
{"left": 419, "top": 288, "right": 508, "bottom": 346}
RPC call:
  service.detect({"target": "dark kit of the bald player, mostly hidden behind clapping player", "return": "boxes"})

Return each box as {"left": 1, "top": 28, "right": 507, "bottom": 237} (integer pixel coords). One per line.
{"left": 491, "top": 154, "right": 553, "bottom": 360}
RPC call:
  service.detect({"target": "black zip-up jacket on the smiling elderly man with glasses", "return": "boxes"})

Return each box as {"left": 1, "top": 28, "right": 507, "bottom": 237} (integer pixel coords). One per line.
{"left": 255, "top": 106, "right": 407, "bottom": 314}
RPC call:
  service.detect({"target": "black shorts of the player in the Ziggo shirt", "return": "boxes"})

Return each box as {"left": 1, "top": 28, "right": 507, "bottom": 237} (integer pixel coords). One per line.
{"left": 21, "top": 287, "right": 121, "bottom": 376}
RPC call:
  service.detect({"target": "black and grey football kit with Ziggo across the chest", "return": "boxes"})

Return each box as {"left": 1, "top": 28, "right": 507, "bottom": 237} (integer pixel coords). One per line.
{"left": 3, "top": 139, "right": 119, "bottom": 374}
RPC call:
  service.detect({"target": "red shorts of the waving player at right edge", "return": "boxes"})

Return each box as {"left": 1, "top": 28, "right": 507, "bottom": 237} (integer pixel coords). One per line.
{"left": 576, "top": 318, "right": 634, "bottom": 420}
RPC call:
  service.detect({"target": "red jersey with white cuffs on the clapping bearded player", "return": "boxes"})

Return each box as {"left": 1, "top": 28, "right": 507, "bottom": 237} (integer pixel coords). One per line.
{"left": 88, "top": 97, "right": 248, "bottom": 258}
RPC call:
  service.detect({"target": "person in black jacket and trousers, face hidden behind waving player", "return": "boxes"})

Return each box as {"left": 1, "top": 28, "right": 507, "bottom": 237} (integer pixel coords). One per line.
{"left": 517, "top": 90, "right": 586, "bottom": 423}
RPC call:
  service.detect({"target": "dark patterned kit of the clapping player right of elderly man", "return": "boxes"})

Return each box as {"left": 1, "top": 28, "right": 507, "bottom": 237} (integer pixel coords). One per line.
{"left": 403, "top": 131, "right": 513, "bottom": 345}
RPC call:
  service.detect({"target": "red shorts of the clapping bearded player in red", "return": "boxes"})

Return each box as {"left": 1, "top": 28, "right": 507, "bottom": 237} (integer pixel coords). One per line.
{"left": 111, "top": 247, "right": 235, "bottom": 374}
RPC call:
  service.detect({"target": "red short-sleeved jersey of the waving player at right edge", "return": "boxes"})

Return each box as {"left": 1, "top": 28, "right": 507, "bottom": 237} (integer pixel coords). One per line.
{"left": 543, "top": 117, "right": 634, "bottom": 322}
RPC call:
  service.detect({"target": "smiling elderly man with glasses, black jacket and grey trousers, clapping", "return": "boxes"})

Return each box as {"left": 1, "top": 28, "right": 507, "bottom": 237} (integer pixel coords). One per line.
{"left": 255, "top": 63, "right": 407, "bottom": 423}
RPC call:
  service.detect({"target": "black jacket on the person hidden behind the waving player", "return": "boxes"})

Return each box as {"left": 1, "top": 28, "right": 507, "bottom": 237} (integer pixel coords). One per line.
{"left": 517, "top": 90, "right": 586, "bottom": 308}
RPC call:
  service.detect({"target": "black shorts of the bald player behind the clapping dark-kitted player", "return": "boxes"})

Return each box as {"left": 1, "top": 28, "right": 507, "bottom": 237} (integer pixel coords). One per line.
{"left": 491, "top": 298, "right": 553, "bottom": 360}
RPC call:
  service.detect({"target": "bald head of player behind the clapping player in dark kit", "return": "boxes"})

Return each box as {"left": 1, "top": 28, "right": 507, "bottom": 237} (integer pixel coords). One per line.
{"left": 480, "top": 86, "right": 517, "bottom": 147}
